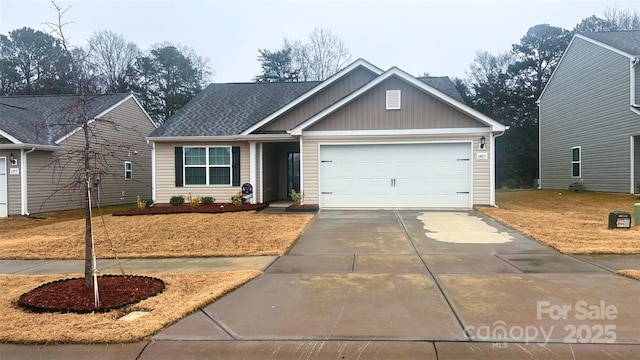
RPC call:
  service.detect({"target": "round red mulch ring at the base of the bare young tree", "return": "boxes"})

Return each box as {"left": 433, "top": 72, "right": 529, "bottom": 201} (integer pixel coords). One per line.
{"left": 18, "top": 275, "right": 164, "bottom": 314}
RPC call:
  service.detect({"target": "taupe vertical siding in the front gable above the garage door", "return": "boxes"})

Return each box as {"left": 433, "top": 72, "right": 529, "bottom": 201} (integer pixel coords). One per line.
{"left": 308, "top": 77, "right": 484, "bottom": 131}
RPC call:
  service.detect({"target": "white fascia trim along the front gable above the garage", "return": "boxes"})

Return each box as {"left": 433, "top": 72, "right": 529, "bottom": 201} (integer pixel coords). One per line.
{"left": 291, "top": 67, "right": 505, "bottom": 135}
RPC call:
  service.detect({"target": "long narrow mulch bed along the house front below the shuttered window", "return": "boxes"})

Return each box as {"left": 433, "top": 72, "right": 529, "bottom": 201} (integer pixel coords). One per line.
{"left": 113, "top": 203, "right": 269, "bottom": 216}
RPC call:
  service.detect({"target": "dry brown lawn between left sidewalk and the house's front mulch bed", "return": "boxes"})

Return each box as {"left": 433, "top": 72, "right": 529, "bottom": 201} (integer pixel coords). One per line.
{"left": 0, "top": 211, "right": 313, "bottom": 259}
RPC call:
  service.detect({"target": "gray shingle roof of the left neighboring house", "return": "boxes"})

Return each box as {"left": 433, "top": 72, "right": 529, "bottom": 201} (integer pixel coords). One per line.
{"left": 0, "top": 94, "right": 129, "bottom": 145}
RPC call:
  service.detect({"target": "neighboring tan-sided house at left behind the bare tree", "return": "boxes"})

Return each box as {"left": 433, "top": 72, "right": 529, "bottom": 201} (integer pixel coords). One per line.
{"left": 0, "top": 94, "right": 156, "bottom": 217}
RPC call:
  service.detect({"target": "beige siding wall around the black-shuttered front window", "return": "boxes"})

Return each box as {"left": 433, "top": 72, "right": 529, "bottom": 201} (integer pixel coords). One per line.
{"left": 154, "top": 142, "right": 250, "bottom": 204}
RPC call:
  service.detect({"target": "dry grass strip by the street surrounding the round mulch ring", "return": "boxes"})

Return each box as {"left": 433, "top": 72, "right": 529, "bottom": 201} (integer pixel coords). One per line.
{"left": 0, "top": 270, "right": 260, "bottom": 343}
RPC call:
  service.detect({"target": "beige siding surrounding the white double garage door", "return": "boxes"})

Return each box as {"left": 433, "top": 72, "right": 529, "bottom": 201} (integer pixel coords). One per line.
{"left": 302, "top": 134, "right": 493, "bottom": 205}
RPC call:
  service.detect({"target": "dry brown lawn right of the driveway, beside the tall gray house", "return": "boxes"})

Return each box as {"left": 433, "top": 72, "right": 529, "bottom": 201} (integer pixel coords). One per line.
{"left": 478, "top": 190, "right": 640, "bottom": 254}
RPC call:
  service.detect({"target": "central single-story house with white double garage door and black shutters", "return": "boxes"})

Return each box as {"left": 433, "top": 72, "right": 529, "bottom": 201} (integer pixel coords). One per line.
{"left": 148, "top": 59, "right": 505, "bottom": 208}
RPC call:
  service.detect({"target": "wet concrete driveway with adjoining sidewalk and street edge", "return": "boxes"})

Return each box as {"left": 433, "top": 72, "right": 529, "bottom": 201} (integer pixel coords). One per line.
{"left": 0, "top": 210, "right": 640, "bottom": 359}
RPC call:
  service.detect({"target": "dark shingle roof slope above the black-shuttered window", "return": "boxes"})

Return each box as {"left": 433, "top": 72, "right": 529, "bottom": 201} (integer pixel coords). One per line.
{"left": 150, "top": 81, "right": 320, "bottom": 137}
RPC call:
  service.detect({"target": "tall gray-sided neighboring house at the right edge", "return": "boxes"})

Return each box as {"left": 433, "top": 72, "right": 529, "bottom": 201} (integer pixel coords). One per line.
{"left": 539, "top": 30, "right": 640, "bottom": 194}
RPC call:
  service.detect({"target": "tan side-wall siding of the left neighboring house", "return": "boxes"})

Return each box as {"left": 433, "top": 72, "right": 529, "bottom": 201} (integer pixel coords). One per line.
{"left": 27, "top": 99, "right": 155, "bottom": 212}
